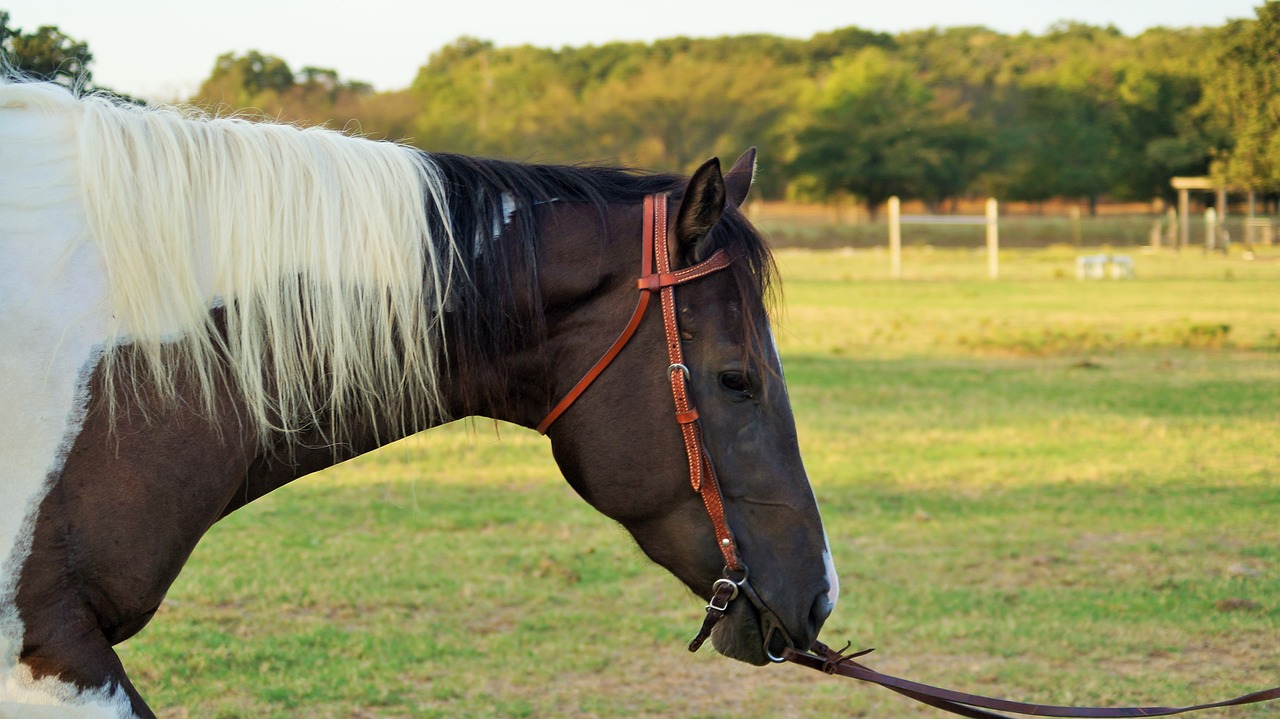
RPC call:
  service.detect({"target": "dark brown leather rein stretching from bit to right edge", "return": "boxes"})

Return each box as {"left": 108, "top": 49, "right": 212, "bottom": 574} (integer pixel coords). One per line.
{"left": 782, "top": 642, "right": 1280, "bottom": 719}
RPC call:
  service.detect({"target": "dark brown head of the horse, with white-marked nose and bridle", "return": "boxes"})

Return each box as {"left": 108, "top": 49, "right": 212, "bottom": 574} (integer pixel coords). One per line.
{"left": 532, "top": 150, "right": 838, "bottom": 664}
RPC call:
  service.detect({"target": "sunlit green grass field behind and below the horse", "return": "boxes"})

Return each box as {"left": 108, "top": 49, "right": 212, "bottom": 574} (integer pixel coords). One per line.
{"left": 120, "top": 248, "right": 1280, "bottom": 719}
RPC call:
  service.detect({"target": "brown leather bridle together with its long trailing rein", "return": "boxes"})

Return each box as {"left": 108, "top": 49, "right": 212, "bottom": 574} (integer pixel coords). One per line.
{"left": 538, "top": 193, "right": 1280, "bottom": 719}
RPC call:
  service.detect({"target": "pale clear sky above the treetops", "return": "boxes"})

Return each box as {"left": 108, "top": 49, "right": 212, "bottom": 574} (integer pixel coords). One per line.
{"left": 0, "top": 0, "right": 1261, "bottom": 100}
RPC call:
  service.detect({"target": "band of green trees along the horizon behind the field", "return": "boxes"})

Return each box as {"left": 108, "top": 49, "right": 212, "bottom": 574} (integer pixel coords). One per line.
{"left": 0, "top": 0, "right": 1280, "bottom": 211}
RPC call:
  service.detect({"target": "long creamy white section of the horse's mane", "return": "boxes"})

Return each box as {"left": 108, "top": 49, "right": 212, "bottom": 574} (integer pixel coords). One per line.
{"left": 0, "top": 81, "right": 456, "bottom": 439}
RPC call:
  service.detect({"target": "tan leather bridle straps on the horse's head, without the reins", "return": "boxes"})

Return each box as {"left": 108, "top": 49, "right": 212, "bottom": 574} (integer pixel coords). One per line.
{"left": 538, "top": 193, "right": 773, "bottom": 661}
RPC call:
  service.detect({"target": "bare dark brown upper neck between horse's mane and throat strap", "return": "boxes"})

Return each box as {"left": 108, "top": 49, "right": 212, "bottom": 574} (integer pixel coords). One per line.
{"left": 430, "top": 195, "right": 640, "bottom": 427}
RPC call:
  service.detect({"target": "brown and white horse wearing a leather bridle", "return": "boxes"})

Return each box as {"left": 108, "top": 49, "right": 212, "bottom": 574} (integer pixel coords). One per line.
{"left": 0, "top": 78, "right": 838, "bottom": 719}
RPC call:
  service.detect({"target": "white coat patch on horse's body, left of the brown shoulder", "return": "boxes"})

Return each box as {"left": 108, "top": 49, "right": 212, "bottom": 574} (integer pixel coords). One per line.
{"left": 0, "top": 82, "right": 133, "bottom": 719}
